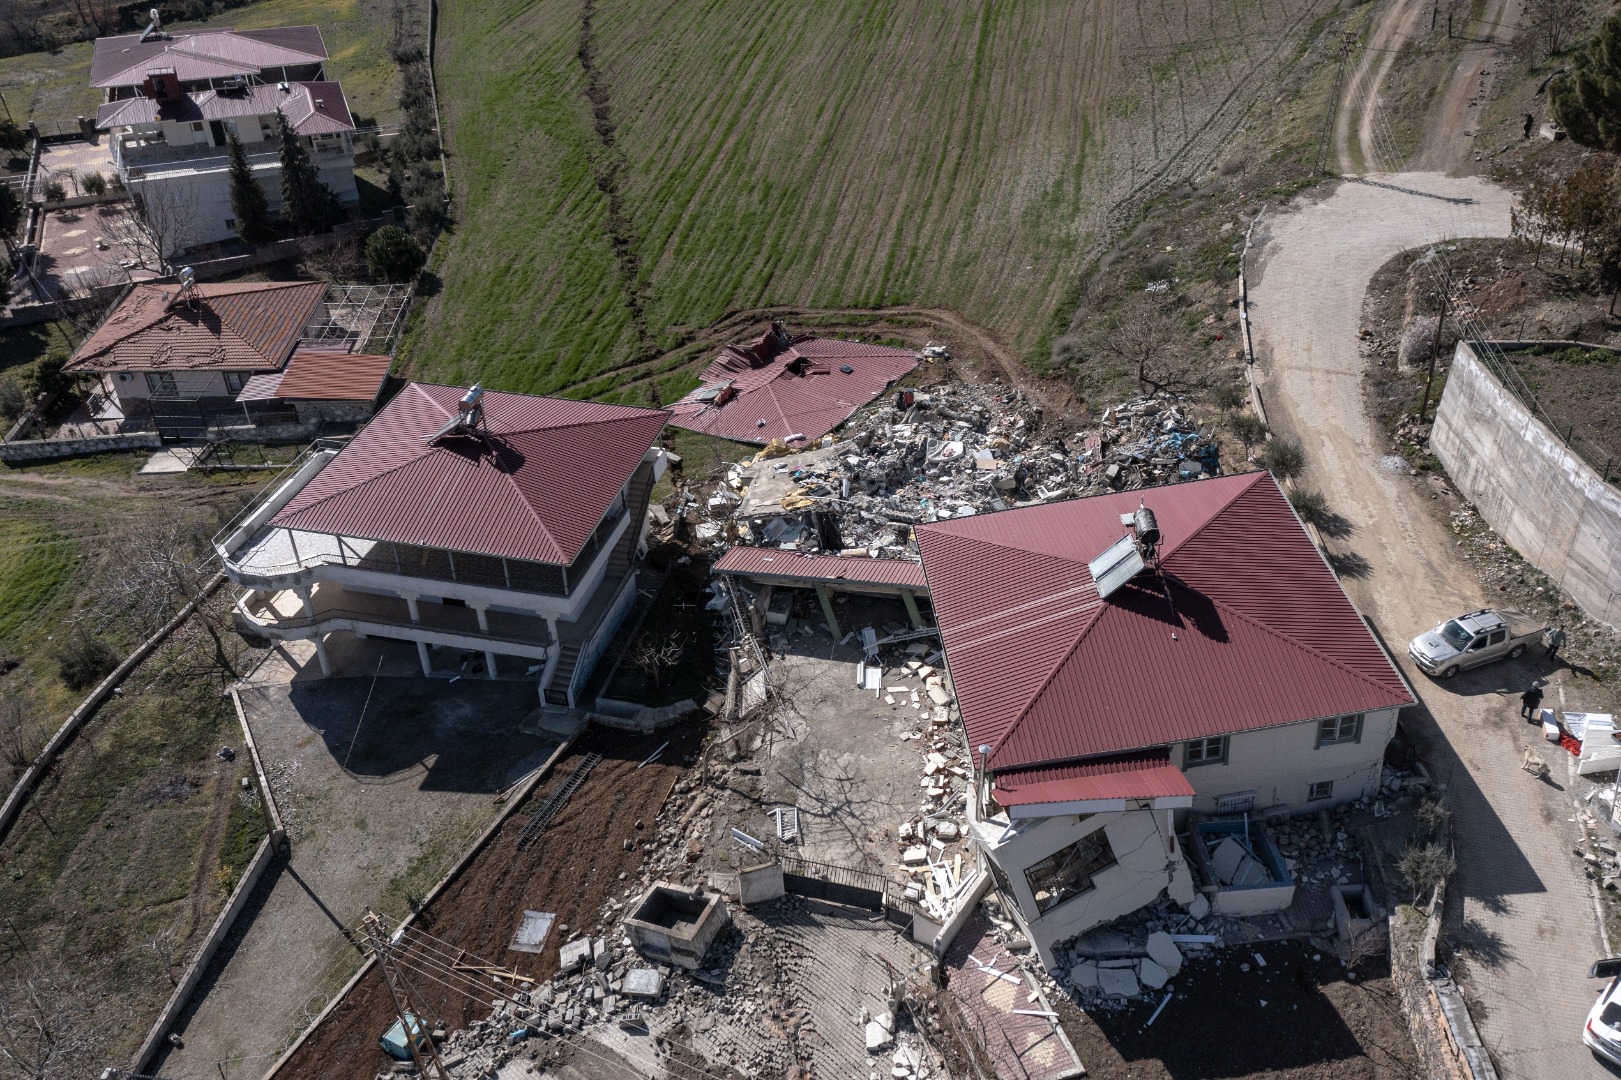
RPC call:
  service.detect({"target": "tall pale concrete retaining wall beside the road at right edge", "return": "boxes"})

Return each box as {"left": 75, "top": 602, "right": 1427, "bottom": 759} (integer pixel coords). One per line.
{"left": 1430, "top": 342, "right": 1621, "bottom": 629}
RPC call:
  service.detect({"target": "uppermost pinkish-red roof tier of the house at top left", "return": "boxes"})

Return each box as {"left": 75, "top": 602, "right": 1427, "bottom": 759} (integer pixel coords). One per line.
{"left": 91, "top": 26, "right": 327, "bottom": 89}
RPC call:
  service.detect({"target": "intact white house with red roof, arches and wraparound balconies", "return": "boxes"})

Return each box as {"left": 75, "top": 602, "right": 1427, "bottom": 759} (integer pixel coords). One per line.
{"left": 216, "top": 383, "right": 668, "bottom": 707}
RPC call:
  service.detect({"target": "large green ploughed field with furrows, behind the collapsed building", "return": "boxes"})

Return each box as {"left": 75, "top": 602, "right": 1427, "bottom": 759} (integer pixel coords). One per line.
{"left": 405, "top": 0, "right": 1331, "bottom": 402}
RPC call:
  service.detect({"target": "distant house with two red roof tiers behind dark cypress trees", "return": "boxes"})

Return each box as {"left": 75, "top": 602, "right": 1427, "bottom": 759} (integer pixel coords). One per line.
{"left": 91, "top": 26, "right": 360, "bottom": 246}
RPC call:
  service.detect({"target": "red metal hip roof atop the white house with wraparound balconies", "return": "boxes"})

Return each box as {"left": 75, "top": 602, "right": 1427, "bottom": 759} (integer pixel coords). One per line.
{"left": 271, "top": 383, "right": 668, "bottom": 564}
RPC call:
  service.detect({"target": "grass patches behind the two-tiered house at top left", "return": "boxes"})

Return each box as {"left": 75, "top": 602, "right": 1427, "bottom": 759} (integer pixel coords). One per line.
{"left": 0, "top": 0, "right": 399, "bottom": 130}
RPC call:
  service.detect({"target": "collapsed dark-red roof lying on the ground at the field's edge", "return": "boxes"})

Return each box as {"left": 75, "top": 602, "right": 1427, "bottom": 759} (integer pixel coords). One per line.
{"left": 669, "top": 323, "right": 917, "bottom": 444}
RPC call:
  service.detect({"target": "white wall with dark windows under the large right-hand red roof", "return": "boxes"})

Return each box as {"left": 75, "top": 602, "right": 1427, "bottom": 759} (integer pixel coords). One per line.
{"left": 1172, "top": 709, "right": 1397, "bottom": 814}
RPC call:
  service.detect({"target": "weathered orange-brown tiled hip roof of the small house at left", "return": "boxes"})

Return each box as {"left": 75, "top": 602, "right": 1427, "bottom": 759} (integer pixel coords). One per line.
{"left": 66, "top": 281, "right": 326, "bottom": 371}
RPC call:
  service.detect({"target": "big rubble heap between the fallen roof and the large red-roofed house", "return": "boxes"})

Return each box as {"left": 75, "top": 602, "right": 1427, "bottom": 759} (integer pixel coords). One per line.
{"left": 703, "top": 383, "right": 1219, "bottom": 555}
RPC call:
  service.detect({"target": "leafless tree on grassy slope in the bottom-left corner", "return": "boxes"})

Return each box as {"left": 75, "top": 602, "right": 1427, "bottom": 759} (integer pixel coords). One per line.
{"left": 0, "top": 949, "right": 118, "bottom": 1080}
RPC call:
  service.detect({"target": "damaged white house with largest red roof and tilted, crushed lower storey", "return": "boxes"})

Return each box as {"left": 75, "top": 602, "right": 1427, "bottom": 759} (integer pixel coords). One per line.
{"left": 917, "top": 472, "right": 1414, "bottom": 965}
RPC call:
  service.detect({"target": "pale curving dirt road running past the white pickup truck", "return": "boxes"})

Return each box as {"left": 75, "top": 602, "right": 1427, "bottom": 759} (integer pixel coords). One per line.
{"left": 1250, "top": 174, "right": 1608, "bottom": 1080}
